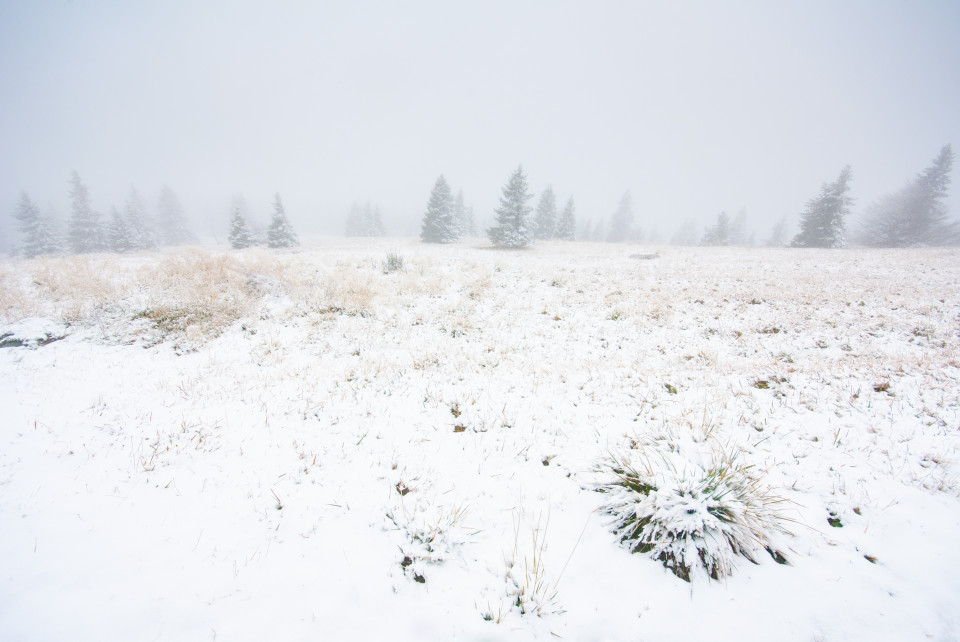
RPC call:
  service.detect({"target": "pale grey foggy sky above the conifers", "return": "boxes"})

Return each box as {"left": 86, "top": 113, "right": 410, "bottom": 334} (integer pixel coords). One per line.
{"left": 0, "top": 0, "right": 960, "bottom": 241}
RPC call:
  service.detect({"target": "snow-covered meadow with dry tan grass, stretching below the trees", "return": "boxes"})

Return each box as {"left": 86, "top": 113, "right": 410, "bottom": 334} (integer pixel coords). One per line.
{"left": 0, "top": 240, "right": 960, "bottom": 642}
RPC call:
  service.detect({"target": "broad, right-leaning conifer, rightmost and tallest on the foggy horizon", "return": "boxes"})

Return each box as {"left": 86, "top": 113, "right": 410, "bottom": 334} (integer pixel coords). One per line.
{"left": 858, "top": 144, "right": 960, "bottom": 247}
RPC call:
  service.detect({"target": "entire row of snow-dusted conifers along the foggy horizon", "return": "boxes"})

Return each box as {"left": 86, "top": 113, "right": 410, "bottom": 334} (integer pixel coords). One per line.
{"left": 14, "top": 144, "right": 960, "bottom": 258}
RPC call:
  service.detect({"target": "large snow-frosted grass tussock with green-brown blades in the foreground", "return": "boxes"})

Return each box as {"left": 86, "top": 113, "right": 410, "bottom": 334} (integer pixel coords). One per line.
{"left": 598, "top": 440, "right": 786, "bottom": 582}
